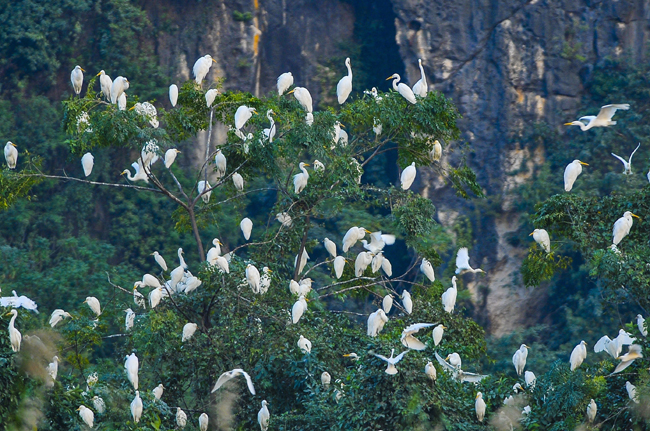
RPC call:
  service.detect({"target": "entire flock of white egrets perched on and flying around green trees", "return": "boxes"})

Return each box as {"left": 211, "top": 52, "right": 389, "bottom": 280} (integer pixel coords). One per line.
{"left": 1, "top": 51, "right": 650, "bottom": 431}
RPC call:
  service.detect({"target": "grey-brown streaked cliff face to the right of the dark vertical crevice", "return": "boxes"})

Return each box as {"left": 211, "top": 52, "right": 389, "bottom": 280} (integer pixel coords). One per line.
{"left": 392, "top": 0, "right": 650, "bottom": 335}
